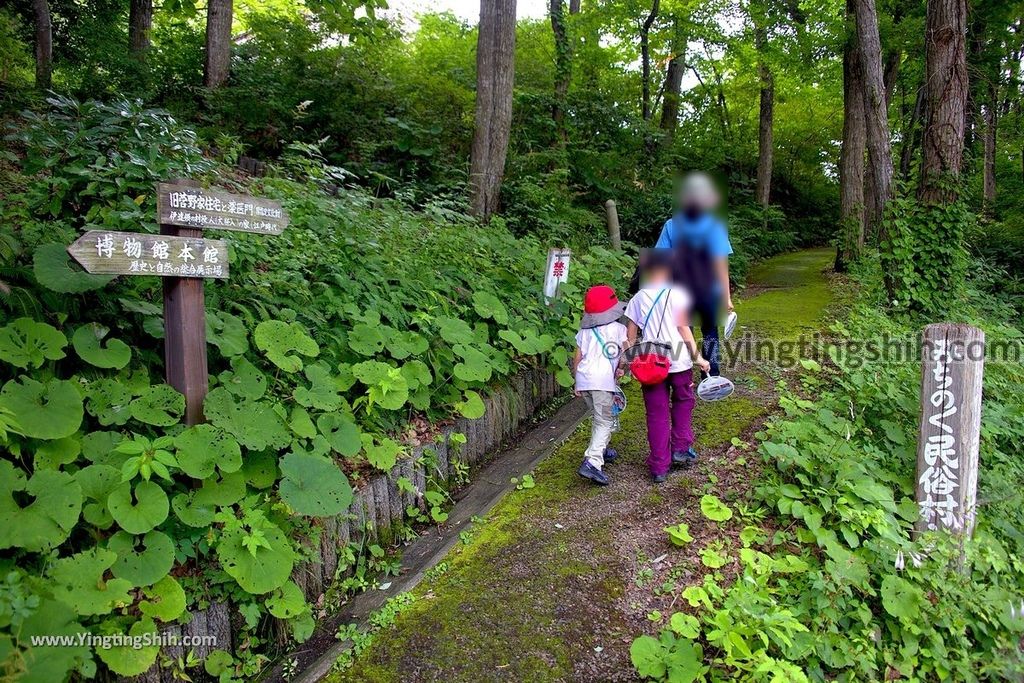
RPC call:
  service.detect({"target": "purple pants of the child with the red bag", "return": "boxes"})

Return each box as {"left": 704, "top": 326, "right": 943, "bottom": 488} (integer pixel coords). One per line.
{"left": 643, "top": 370, "right": 695, "bottom": 476}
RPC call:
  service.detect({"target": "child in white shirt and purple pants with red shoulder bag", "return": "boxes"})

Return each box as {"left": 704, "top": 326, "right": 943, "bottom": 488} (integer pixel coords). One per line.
{"left": 626, "top": 250, "right": 710, "bottom": 483}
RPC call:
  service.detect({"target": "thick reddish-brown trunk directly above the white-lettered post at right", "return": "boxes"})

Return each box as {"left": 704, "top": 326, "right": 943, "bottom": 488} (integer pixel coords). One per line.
{"left": 918, "top": 0, "right": 968, "bottom": 204}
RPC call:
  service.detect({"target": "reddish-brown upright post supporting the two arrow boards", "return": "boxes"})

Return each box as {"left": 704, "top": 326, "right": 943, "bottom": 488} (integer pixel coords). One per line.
{"left": 160, "top": 225, "right": 210, "bottom": 425}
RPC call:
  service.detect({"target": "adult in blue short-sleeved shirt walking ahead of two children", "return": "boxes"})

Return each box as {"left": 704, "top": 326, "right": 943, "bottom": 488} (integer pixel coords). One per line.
{"left": 654, "top": 173, "right": 733, "bottom": 377}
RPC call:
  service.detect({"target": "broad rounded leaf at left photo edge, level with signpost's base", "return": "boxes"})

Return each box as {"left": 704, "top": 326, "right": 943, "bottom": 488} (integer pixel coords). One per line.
{"left": 0, "top": 377, "right": 85, "bottom": 439}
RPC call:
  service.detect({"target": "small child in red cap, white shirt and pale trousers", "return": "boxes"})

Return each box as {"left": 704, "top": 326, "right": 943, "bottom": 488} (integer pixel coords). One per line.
{"left": 572, "top": 285, "right": 626, "bottom": 486}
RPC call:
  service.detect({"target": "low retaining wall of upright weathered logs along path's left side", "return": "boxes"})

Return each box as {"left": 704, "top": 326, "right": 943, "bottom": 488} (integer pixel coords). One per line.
{"left": 126, "top": 369, "right": 562, "bottom": 683}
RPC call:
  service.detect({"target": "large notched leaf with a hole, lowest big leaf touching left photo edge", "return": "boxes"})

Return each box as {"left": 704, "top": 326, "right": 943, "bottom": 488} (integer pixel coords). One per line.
{"left": 0, "top": 460, "right": 82, "bottom": 552}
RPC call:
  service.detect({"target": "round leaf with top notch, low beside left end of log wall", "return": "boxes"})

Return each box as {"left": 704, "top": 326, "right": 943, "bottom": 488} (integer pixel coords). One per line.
{"left": 217, "top": 522, "right": 295, "bottom": 595}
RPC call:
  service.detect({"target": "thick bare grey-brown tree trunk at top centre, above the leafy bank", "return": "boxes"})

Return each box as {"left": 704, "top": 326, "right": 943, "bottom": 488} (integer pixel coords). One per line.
{"left": 469, "top": 0, "right": 515, "bottom": 223}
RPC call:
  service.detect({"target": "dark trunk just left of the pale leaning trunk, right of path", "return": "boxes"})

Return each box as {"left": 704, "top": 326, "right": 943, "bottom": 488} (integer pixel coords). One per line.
{"left": 836, "top": 5, "right": 867, "bottom": 271}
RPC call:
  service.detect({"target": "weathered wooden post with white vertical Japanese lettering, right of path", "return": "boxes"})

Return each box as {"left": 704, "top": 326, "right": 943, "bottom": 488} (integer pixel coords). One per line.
{"left": 914, "top": 323, "right": 985, "bottom": 537}
